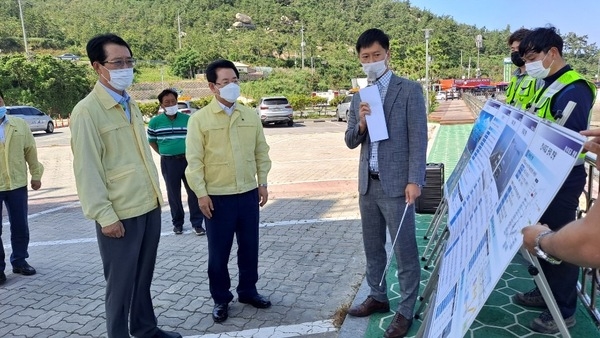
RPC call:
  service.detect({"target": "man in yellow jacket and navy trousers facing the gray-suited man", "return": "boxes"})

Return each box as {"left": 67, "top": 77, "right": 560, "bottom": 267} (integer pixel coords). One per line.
{"left": 185, "top": 60, "right": 271, "bottom": 323}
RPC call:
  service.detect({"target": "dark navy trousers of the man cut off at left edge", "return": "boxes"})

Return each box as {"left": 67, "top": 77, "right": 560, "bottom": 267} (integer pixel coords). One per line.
{"left": 0, "top": 186, "right": 29, "bottom": 272}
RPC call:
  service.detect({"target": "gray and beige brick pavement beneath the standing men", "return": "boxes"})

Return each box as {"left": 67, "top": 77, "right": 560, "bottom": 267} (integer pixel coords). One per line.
{"left": 0, "top": 122, "right": 364, "bottom": 338}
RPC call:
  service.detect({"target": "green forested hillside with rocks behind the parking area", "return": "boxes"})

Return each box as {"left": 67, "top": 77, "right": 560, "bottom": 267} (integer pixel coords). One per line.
{"left": 0, "top": 0, "right": 599, "bottom": 88}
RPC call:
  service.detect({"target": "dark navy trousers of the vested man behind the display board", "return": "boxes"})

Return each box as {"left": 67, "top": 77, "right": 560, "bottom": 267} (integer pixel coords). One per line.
{"left": 539, "top": 166, "right": 586, "bottom": 318}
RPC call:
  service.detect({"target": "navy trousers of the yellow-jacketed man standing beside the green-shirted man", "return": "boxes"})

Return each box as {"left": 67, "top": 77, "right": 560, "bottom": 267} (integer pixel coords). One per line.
{"left": 206, "top": 189, "right": 259, "bottom": 304}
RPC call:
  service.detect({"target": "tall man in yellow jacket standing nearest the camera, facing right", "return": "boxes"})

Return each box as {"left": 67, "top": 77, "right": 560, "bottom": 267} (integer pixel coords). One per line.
{"left": 71, "top": 34, "right": 181, "bottom": 338}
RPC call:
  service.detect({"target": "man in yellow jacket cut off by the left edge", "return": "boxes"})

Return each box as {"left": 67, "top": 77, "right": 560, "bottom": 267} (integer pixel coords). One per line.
{"left": 0, "top": 92, "right": 44, "bottom": 284}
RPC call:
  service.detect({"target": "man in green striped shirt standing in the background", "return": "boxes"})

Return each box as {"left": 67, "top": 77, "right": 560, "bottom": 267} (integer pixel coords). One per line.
{"left": 148, "top": 89, "right": 206, "bottom": 236}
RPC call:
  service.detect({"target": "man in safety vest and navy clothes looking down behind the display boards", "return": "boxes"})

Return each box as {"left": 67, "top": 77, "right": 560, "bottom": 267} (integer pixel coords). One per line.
{"left": 514, "top": 27, "right": 596, "bottom": 334}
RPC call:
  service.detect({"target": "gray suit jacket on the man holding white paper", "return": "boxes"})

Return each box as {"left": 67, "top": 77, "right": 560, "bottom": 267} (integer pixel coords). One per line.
{"left": 345, "top": 74, "right": 427, "bottom": 197}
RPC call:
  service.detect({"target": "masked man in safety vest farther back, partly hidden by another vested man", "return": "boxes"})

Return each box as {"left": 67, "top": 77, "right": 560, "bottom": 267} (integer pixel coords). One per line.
{"left": 506, "top": 28, "right": 544, "bottom": 110}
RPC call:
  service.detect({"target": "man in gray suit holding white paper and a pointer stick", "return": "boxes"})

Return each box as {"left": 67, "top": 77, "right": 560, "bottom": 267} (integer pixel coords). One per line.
{"left": 345, "top": 29, "right": 427, "bottom": 338}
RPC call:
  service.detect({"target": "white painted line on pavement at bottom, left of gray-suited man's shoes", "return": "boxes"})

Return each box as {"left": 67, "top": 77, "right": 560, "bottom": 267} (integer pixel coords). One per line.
{"left": 183, "top": 320, "right": 337, "bottom": 338}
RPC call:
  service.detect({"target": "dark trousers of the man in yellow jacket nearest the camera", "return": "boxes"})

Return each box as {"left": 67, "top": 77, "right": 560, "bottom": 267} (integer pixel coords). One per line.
{"left": 96, "top": 207, "right": 161, "bottom": 338}
